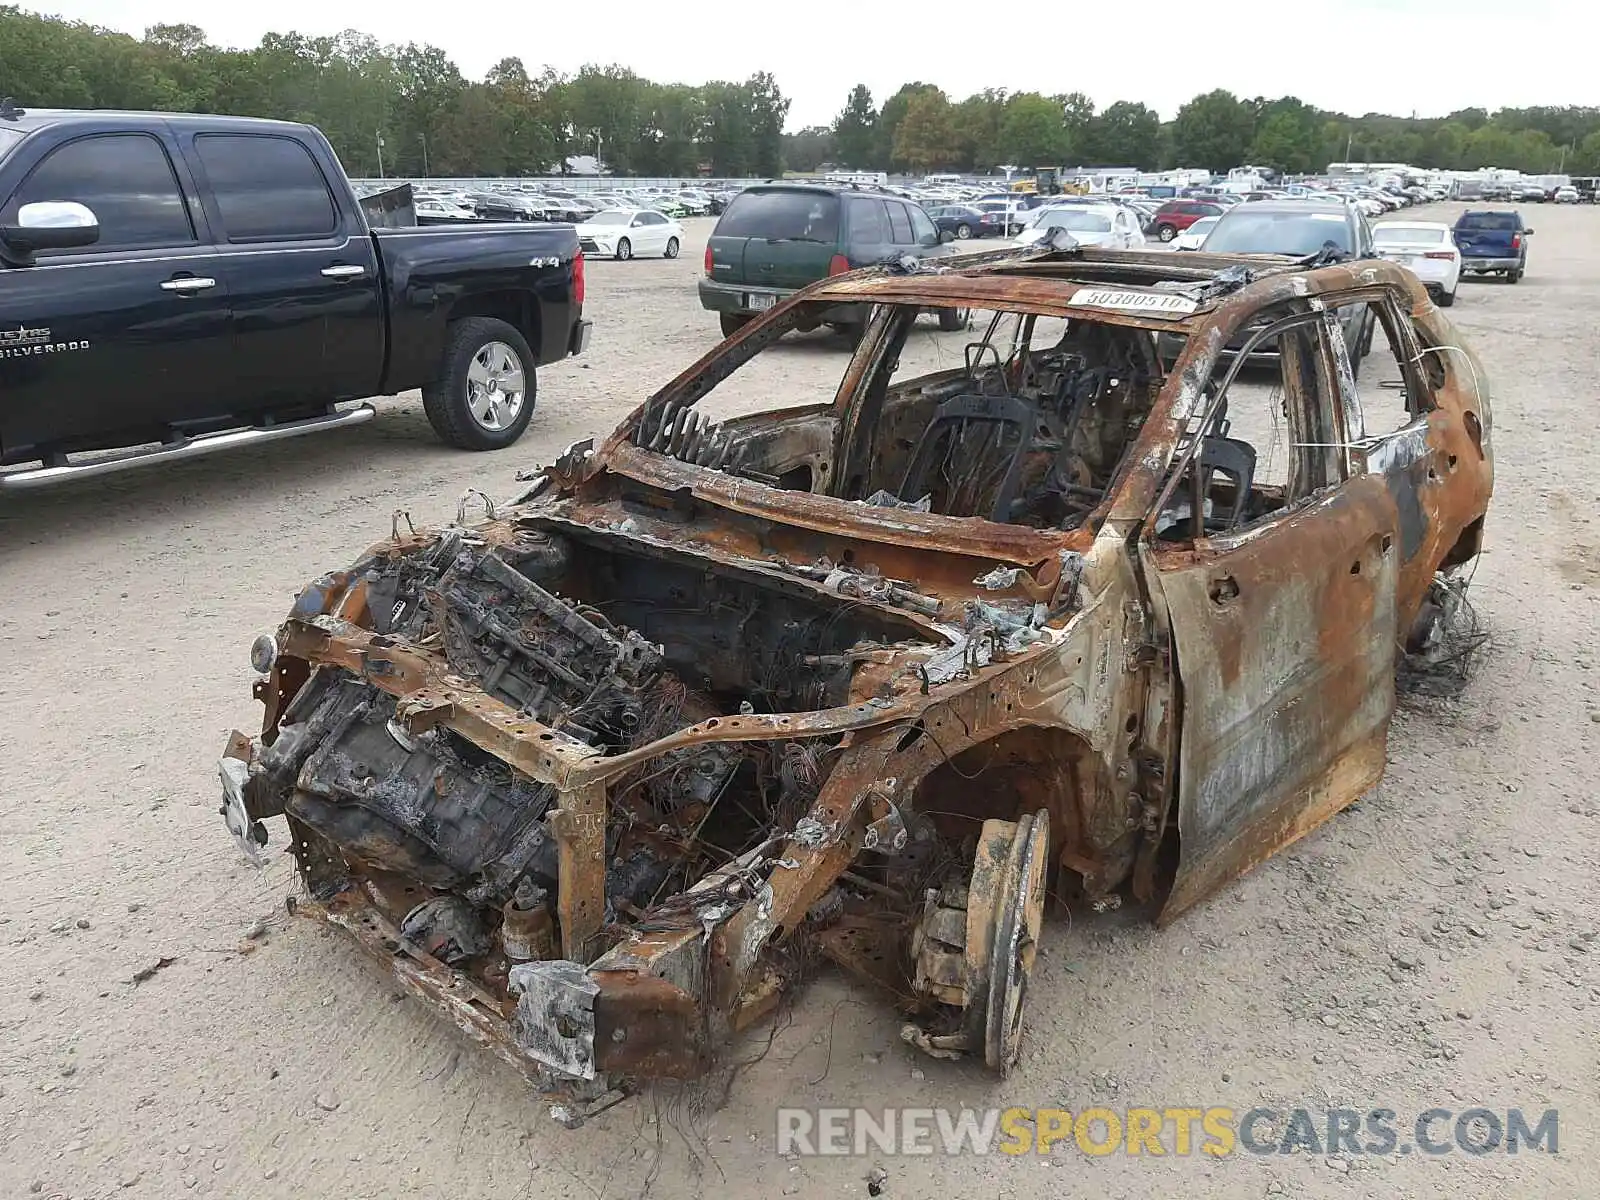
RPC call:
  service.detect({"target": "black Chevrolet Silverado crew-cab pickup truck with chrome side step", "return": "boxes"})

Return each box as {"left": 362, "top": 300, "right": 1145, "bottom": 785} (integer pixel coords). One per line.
{"left": 0, "top": 102, "right": 590, "bottom": 493}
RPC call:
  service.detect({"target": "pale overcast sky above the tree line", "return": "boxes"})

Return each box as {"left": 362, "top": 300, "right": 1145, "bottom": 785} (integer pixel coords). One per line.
{"left": 37, "top": 0, "right": 1600, "bottom": 130}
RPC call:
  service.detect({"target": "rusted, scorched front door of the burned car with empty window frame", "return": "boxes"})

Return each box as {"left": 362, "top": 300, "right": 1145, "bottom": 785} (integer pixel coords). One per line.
{"left": 1136, "top": 305, "right": 1398, "bottom": 923}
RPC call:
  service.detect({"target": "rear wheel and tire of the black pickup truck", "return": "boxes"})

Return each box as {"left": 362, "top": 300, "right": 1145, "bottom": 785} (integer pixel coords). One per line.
{"left": 422, "top": 317, "right": 538, "bottom": 450}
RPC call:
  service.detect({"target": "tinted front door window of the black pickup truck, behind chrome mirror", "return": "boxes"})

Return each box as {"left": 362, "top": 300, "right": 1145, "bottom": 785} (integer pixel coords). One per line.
{"left": 5, "top": 133, "right": 195, "bottom": 253}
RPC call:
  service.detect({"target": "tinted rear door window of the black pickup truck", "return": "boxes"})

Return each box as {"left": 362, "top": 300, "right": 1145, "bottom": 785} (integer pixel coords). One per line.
{"left": 195, "top": 133, "right": 338, "bottom": 242}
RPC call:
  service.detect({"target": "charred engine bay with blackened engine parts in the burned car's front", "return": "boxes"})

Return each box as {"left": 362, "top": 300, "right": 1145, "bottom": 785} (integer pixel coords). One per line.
{"left": 259, "top": 528, "right": 947, "bottom": 965}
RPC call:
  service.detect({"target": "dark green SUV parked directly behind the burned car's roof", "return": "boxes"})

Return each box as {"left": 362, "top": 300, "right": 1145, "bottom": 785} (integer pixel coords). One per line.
{"left": 699, "top": 184, "right": 960, "bottom": 336}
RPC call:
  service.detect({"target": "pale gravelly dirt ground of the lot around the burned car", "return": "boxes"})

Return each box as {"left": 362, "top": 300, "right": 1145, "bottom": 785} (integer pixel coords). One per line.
{"left": 0, "top": 205, "right": 1600, "bottom": 1200}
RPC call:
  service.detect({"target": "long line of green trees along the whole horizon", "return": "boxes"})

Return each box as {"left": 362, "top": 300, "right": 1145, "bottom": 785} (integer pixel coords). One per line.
{"left": 0, "top": 6, "right": 1600, "bottom": 178}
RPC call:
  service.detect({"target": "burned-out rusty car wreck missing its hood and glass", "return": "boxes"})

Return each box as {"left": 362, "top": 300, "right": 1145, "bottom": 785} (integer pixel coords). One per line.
{"left": 222, "top": 248, "right": 1493, "bottom": 1099}
